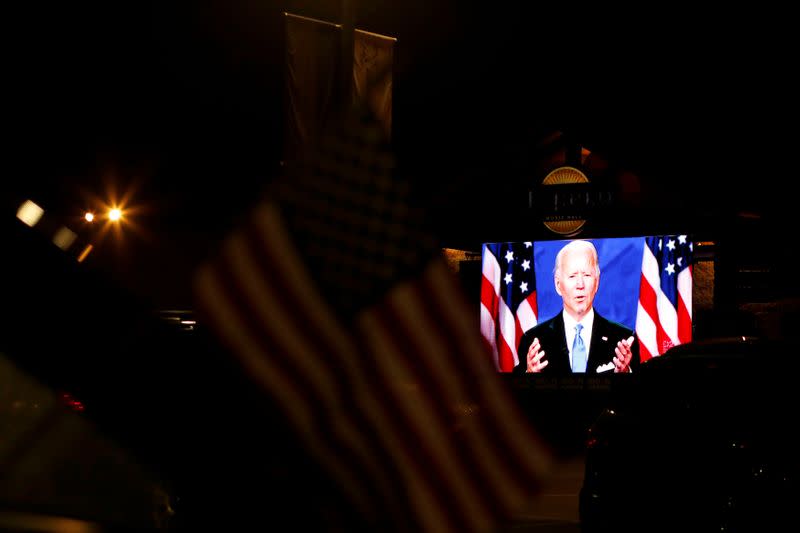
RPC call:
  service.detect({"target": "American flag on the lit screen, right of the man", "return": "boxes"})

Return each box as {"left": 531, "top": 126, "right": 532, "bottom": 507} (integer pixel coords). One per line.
{"left": 636, "top": 235, "right": 692, "bottom": 361}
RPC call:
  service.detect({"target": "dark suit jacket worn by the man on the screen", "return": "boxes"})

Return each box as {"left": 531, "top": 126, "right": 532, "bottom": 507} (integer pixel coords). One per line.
{"left": 514, "top": 309, "right": 639, "bottom": 375}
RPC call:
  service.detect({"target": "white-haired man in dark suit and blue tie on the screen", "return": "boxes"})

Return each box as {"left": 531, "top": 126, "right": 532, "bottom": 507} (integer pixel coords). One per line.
{"left": 514, "top": 241, "right": 639, "bottom": 375}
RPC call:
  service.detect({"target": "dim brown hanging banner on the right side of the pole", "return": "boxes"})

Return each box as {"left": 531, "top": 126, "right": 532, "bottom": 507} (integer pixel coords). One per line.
{"left": 353, "top": 29, "right": 397, "bottom": 139}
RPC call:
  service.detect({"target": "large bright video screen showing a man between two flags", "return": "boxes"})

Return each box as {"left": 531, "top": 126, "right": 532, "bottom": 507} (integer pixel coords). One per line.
{"left": 480, "top": 235, "right": 693, "bottom": 374}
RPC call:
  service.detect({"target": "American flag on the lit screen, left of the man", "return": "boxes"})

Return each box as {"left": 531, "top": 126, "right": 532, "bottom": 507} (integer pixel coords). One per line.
{"left": 481, "top": 242, "right": 538, "bottom": 372}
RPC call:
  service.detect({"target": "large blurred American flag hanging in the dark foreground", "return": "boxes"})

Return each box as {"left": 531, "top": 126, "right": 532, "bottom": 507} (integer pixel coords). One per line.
{"left": 196, "top": 105, "right": 552, "bottom": 532}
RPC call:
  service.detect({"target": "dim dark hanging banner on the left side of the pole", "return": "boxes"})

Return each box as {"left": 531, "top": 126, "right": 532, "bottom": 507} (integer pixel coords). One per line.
{"left": 284, "top": 12, "right": 341, "bottom": 161}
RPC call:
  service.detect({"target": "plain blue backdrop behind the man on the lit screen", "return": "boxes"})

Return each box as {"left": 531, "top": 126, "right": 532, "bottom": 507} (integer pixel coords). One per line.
{"left": 533, "top": 237, "right": 644, "bottom": 329}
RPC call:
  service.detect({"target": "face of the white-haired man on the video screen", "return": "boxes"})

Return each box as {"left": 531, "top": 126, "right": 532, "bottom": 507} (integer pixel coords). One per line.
{"left": 555, "top": 246, "right": 600, "bottom": 320}
